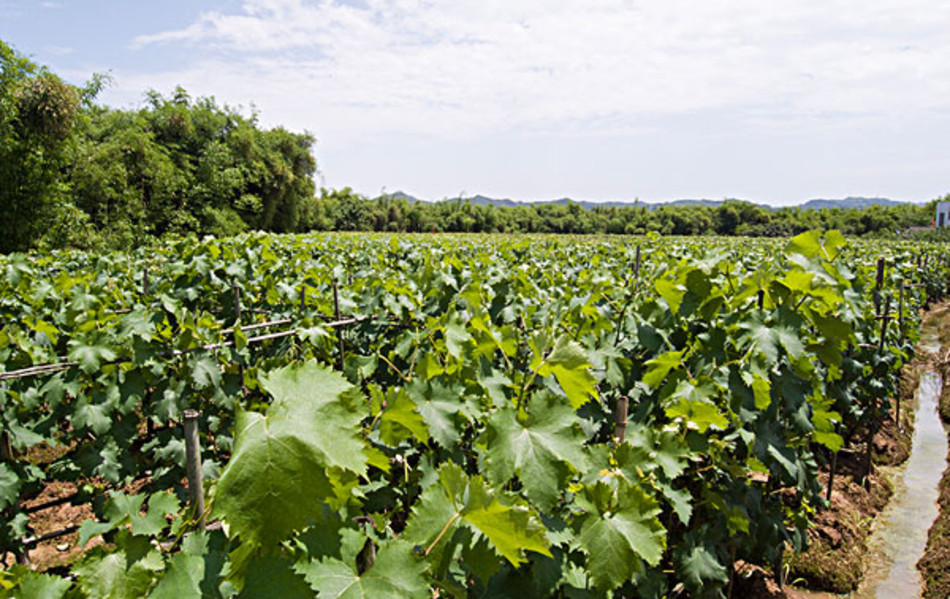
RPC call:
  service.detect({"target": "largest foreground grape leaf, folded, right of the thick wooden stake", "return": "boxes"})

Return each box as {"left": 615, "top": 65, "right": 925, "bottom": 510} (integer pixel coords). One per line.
{"left": 213, "top": 363, "right": 366, "bottom": 545}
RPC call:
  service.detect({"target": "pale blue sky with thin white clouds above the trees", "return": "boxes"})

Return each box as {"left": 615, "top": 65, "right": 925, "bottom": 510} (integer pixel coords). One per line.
{"left": 0, "top": 0, "right": 950, "bottom": 205}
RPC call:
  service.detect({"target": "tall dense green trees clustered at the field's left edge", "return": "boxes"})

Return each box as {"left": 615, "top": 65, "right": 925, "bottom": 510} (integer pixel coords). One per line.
{"left": 0, "top": 41, "right": 316, "bottom": 252}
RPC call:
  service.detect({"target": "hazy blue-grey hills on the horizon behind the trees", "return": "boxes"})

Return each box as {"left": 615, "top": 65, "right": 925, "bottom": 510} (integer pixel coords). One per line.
{"left": 388, "top": 191, "right": 910, "bottom": 210}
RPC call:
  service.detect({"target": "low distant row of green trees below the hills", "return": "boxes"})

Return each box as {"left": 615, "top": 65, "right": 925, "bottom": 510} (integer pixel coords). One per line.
{"left": 309, "top": 188, "right": 936, "bottom": 237}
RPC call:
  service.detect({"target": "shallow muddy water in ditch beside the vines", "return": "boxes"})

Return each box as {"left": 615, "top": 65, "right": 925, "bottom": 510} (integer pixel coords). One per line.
{"left": 852, "top": 371, "right": 947, "bottom": 599}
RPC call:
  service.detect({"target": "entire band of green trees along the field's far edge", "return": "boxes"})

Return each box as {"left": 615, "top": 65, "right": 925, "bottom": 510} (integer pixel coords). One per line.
{"left": 0, "top": 40, "right": 950, "bottom": 252}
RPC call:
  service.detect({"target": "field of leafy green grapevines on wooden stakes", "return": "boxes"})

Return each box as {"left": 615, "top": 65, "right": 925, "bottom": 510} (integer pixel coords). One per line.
{"left": 0, "top": 231, "right": 950, "bottom": 599}
